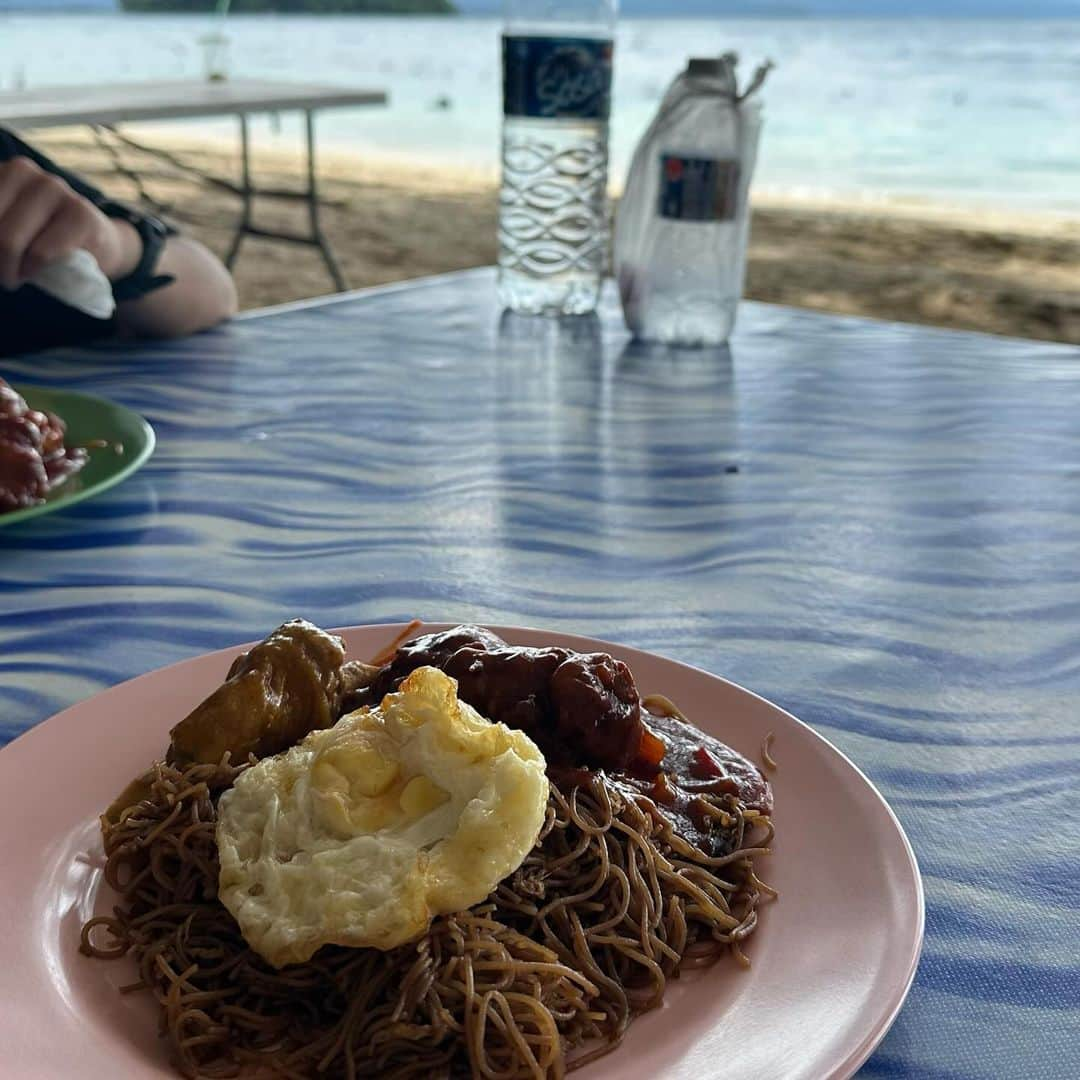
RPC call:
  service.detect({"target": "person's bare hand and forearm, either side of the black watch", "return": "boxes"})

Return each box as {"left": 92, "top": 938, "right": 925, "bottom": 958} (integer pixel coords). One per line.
{"left": 0, "top": 144, "right": 237, "bottom": 337}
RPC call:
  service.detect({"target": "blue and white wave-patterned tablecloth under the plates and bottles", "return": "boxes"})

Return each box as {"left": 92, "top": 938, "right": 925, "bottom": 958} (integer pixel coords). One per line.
{"left": 0, "top": 265, "right": 1080, "bottom": 1080}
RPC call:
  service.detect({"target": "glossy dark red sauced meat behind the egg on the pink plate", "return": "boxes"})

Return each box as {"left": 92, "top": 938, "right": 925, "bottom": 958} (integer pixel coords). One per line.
{"left": 352, "top": 626, "right": 772, "bottom": 855}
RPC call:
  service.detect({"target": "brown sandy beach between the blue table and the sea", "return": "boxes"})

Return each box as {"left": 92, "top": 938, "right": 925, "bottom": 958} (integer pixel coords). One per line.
{"left": 35, "top": 129, "right": 1080, "bottom": 343}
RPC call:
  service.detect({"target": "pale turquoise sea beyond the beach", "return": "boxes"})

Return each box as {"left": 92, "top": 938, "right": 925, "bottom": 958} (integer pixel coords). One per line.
{"left": 0, "top": 14, "right": 1080, "bottom": 211}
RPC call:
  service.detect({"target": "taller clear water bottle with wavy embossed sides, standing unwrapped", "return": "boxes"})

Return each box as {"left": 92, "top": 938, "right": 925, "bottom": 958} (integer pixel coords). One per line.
{"left": 499, "top": 0, "right": 618, "bottom": 315}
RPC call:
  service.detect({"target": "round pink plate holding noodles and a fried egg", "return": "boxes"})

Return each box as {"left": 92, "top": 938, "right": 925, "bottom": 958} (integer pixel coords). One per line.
{"left": 0, "top": 626, "right": 923, "bottom": 1080}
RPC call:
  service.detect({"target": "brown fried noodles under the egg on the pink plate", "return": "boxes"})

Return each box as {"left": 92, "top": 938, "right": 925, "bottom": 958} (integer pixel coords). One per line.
{"left": 81, "top": 759, "right": 773, "bottom": 1080}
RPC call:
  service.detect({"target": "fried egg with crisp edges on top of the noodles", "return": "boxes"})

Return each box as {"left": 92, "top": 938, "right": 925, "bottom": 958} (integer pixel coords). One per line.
{"left": 217, "top": 667, "right": 548, "bottom": 968}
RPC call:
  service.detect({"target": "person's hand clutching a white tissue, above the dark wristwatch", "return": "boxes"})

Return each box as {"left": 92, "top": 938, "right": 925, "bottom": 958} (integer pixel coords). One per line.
{"left": 0, "top": 157, "right": 140, "bottom": 289}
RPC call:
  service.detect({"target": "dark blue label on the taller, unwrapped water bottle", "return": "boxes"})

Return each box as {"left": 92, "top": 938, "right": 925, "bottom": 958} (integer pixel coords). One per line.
{"left": 502, "top": 33, "right": 613, "bottom": 120}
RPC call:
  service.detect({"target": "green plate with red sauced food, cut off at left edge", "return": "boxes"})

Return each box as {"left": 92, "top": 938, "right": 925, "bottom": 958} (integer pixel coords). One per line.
{"left": 0, "top": 387, "right": 154, "bottom": 526}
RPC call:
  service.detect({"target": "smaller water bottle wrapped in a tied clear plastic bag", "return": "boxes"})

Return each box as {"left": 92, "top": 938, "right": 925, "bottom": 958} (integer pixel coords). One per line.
{"left": 615, "top": 54, "right": 771, "bottom": 346}
